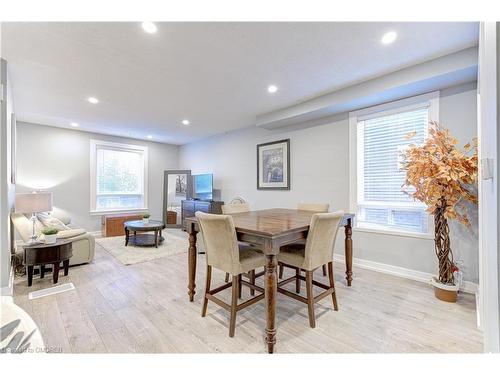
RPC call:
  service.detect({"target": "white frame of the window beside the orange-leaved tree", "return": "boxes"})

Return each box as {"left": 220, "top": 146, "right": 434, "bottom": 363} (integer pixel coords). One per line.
{"left": 349, "top": 91, "right": 439, "bottom": 239}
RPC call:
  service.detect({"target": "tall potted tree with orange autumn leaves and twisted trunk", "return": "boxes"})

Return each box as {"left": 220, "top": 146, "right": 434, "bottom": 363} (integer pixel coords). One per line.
{"left": 402, "top": 121, "right": 477, "bottom": 302}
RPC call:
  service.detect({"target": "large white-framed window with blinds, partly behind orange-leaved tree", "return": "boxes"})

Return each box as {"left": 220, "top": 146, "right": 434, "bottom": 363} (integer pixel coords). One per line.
{"left": 349, "top": 93, "right": 438, "bottom": 235}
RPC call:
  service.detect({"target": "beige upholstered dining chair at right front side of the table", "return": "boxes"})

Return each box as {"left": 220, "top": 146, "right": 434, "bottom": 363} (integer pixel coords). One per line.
{"left": 278, "top": 211, "right": 344, "bottom": 328}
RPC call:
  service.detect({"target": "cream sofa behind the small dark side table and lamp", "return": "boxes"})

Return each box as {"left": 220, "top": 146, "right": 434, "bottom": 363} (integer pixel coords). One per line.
{"left": 11, "top": 213, "right": 95, "bottom": 265}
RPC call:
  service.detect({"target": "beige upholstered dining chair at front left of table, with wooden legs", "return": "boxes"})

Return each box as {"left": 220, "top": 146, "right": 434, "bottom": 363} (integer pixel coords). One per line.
{"left": 195, "top": 212, "right": 265, "bottom": 337}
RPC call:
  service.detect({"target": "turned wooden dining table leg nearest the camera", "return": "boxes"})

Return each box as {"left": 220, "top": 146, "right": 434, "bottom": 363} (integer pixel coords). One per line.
{"left": 264, "top": 255, "right": 278, "bottom": 353}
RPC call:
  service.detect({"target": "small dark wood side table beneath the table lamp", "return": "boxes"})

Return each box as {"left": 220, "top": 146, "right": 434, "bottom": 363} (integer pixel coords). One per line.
{"left": 23, "top": 239, "right": 73, "bottom": 286}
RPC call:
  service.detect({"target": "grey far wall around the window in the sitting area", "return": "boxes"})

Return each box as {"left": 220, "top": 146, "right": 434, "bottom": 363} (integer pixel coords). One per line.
{"left": 17, "top": 122, "right": 178, "bottom": 231}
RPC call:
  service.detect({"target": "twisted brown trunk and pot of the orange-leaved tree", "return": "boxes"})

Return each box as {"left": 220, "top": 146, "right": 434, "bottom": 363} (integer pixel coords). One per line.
{"left": 431, "top": 203, "right": 458, "bottom": 302}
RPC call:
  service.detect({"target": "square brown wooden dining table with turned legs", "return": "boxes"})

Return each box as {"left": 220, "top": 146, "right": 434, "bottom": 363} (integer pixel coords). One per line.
{"left": 185, "top": 208, "right": 355, "bottom": 353}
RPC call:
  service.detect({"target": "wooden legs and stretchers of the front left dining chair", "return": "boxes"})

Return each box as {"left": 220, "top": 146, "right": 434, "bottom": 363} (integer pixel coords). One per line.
{"left": 201, "top": 266, "right": 265, "bottom": 337}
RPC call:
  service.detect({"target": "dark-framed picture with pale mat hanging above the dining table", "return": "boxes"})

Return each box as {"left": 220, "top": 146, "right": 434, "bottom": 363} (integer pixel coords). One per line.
{"left": 257, "top": 139, "right": 290, "bottom": 190}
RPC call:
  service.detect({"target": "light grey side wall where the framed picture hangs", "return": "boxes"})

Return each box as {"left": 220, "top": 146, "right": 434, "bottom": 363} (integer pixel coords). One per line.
{"left": 179, "top": 83, "right": 478, "bottom": 282}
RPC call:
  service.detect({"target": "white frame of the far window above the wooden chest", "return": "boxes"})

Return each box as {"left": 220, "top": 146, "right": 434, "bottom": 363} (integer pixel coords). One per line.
{"left": 90, "top": 139, "right": 149, "bottom": 215}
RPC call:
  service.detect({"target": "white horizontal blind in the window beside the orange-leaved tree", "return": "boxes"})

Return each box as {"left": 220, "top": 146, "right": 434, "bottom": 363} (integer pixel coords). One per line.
{"left": 357, "top": 106, "right": 429, "bottom": 233}
